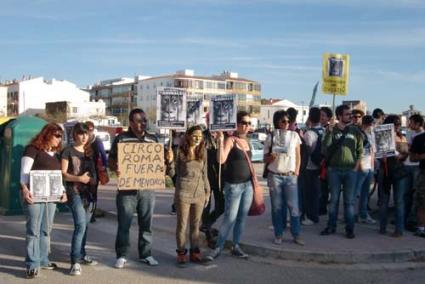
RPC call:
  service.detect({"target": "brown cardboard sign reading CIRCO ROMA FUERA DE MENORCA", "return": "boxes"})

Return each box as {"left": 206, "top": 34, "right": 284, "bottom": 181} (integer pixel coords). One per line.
{"left": 118, "top": 143, "right": 165, "bottom": 190}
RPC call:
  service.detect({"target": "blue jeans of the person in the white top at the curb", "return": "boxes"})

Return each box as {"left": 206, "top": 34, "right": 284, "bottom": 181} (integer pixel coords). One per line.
{"left": 268, "top": 173, "right": 301, "bottom": 238}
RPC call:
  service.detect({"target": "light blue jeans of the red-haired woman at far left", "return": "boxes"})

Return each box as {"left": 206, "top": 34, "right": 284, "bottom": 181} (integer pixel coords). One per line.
{"left": 24, "top": 203, "right": 56, "bottom": 270}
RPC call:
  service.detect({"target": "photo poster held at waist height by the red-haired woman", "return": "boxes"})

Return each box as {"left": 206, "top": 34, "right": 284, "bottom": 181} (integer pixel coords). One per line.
{"left": 30, "top": 171, "right": 64, "bottom": 203}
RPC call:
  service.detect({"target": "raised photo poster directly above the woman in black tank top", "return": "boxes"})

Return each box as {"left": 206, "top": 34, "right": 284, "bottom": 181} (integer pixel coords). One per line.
{"left": 209, "top": 95, "right": 237, "bottom": 131}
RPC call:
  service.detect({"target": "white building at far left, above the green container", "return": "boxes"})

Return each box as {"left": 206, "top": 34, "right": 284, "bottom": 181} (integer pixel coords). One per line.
{"left": 6, "top": 77, "right": 90, "bottom": 116}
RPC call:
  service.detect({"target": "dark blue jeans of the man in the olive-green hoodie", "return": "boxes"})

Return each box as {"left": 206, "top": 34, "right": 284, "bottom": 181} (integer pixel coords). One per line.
{"left": 328, "top": 168, "right": 357, "bottom": 232}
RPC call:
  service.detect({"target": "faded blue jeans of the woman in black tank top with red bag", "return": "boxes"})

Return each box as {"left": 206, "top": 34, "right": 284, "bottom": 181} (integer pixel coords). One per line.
{"left": 216, "top": 181, "right": 253, "bottom": 249}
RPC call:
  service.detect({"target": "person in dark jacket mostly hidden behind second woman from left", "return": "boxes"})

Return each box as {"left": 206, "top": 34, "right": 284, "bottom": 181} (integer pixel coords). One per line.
{"left": 86, "top": 121, "right": 108, "bottom": 223}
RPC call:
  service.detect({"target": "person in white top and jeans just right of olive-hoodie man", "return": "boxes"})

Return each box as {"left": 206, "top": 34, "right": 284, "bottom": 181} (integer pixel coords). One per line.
{"left": 353, "top": 114, "right": 376, "bottom": 224}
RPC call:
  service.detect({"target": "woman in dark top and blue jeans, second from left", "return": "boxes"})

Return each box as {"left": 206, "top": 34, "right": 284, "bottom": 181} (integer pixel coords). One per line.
{"left": 61, "top": 123, "right": 97, "bottom": 276}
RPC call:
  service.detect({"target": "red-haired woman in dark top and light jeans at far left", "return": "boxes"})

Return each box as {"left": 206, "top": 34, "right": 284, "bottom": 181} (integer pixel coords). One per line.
{"left": 20, "top": 123, "right": 66, "bottom": 278}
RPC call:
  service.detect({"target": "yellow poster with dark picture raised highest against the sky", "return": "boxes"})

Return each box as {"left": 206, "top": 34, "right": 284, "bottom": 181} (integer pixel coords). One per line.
{"left": 322, "top": 53, "right": 350, "bottom": 96}
